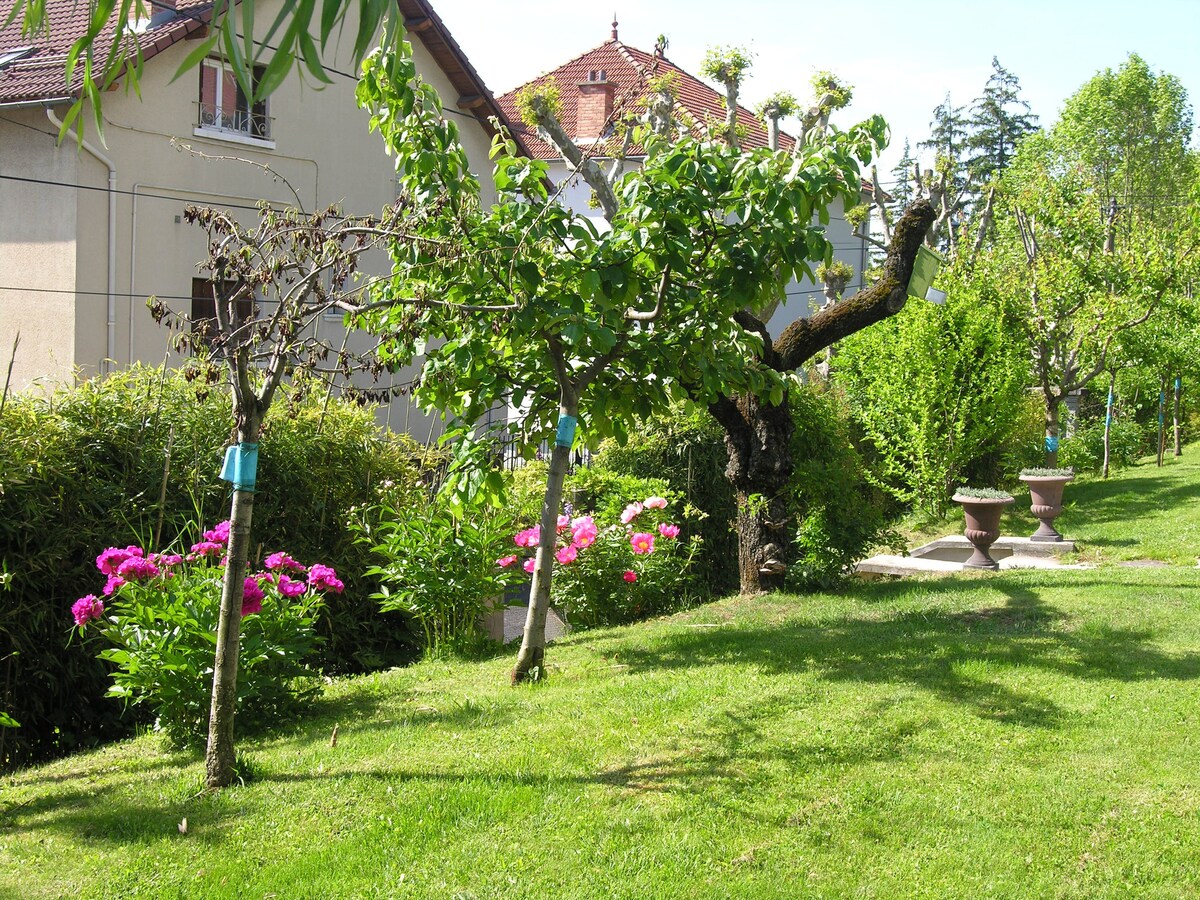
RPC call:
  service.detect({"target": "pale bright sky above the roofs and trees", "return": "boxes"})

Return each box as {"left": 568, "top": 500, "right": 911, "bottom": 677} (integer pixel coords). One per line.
{"left": 434, "top": 0, "right": 1200, "bottom": 181}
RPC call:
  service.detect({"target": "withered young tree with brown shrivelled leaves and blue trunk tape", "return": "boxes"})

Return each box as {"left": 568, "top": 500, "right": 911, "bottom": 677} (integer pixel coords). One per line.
{"left": 149, "top": 200, "right": 413, "bottom": 787}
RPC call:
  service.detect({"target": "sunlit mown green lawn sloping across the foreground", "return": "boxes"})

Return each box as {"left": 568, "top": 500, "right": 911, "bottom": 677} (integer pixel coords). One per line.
{"left": 0, "top": 448, "right": 1200, "bottom": 898}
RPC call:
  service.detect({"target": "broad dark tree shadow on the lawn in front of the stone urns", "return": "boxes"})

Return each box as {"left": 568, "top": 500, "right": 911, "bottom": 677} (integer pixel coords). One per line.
{"left": 590, "top": 580, "right": 1200, "bottom": 727}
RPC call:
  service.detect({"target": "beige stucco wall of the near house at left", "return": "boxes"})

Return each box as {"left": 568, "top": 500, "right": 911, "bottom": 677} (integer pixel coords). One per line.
{"left": 0, "top": 0, "right": 491, "bottom": 438}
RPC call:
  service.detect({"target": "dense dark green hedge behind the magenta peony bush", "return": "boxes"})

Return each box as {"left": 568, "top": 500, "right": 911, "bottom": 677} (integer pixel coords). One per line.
{"left": 0, "top": 367, "right": 424, "bottom": 768}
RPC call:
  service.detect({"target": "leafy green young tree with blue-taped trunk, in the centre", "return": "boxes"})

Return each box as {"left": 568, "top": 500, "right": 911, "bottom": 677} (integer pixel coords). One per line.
{"left": 359, "top": 42, "right": 919, "bottom": 682}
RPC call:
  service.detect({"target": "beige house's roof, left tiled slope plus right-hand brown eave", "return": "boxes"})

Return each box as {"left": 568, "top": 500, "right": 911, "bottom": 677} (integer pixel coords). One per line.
{"left": 0, "top": 0, "right": 525, "bottom": 150}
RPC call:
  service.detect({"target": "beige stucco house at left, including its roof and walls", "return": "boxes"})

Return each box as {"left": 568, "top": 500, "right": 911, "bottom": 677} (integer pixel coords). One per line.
{"left": 0, "top": 0, "right": 516, "bottom": 438}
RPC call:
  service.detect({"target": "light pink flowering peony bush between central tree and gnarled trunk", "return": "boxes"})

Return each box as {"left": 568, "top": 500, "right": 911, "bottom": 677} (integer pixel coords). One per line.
{"left": 496, "top": 496, "right": 698, "bottom": 628}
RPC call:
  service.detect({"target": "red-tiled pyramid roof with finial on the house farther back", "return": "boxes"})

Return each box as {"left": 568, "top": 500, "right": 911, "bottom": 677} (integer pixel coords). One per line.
{"left": 498, "top": 23, "right": 796, "bottom": 160}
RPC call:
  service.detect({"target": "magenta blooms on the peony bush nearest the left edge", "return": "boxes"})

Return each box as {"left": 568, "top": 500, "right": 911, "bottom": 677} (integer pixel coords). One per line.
{"left": 71, "top": 522, "right": 346, "bottom": 628}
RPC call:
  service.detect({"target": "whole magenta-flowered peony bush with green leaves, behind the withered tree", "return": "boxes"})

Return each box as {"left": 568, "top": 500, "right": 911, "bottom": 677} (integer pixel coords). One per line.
{"left": 71, "top": 522, "right": 344, "bottom": 745}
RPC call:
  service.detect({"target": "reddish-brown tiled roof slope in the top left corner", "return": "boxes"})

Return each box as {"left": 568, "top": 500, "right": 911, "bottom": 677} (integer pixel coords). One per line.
{"left": 0, "top": 0, "right": 212, "bottom": 106}
